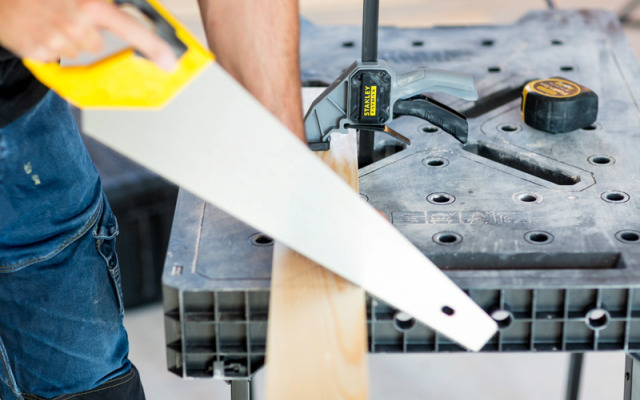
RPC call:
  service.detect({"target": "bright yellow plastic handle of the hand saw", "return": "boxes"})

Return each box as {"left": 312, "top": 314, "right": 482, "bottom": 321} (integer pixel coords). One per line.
{"left": 22, "top": 0, "right": 213, "bottom": 108}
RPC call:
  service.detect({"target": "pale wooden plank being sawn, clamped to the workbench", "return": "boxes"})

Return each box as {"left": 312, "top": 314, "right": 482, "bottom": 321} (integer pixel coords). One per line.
{"left": 265, "top": 132, "right": 369, "bottom": 400}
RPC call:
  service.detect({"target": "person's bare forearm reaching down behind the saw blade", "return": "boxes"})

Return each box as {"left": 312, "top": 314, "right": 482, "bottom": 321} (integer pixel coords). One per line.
{"left": 198, "top": 0, "right": 305, "bottom": 140}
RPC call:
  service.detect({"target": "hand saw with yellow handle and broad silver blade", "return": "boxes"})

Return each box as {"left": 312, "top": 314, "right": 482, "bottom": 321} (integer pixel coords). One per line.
{"left": 24, "top": 0, "right": 497, "bottom": 351}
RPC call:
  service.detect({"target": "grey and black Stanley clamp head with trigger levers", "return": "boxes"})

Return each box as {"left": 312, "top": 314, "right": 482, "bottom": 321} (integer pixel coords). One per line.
{"left": 304, "top": 60, "right": 478, "bottom": 151}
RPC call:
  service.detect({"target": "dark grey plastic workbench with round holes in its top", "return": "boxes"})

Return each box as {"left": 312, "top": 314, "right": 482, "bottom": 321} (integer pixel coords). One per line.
{"left": 163, "top": 10, "right": 640, "bottom": 399}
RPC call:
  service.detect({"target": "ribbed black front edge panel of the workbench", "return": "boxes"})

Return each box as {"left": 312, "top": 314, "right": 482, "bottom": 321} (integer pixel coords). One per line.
{"left": 165, "top": 288, "right": 640, "bottom": 379}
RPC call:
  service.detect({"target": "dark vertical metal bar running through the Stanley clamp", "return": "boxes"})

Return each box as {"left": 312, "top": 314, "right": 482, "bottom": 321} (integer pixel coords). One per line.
{"left": 358, "top": 0, "right": 380, "bottom": 168}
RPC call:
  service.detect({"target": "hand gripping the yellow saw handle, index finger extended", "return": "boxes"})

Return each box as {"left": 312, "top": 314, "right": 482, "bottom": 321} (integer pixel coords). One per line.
{"left": 0, "top": 0, "right": 176, "bottom": 70}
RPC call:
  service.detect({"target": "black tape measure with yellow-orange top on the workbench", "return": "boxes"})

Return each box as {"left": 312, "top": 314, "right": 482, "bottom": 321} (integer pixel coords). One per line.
{"left": 522, "top": 77, "right": 598, "bottom": 133}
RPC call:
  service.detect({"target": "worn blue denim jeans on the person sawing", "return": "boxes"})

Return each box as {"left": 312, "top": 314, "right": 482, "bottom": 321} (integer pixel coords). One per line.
{"left": 0, "top": 92, "right": 141, "bottom": 400}
